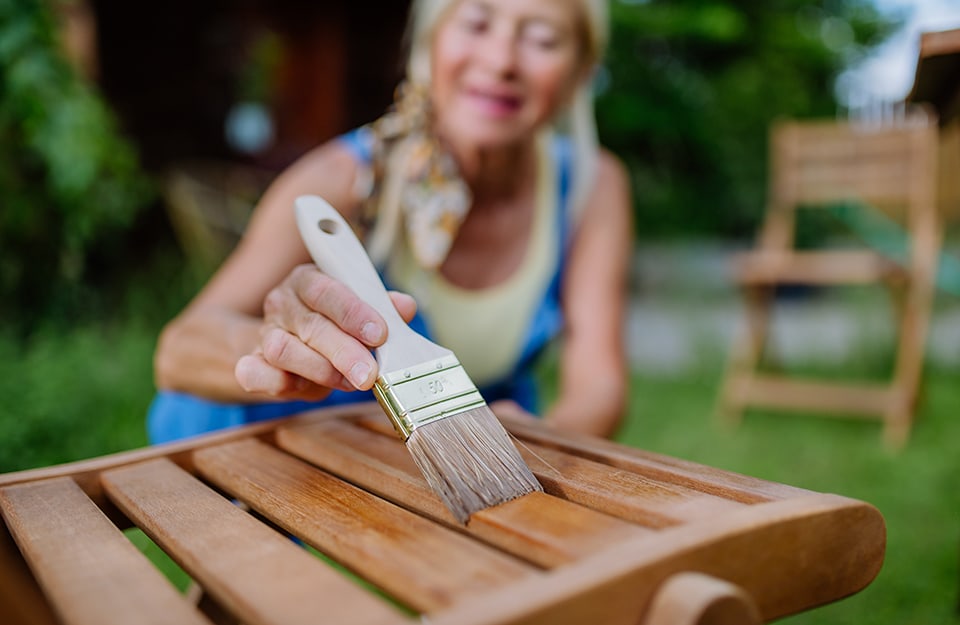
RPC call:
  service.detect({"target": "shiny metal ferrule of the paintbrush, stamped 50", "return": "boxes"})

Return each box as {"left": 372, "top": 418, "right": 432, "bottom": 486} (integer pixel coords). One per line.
{"left": 373, "top": 356, "right": 486, "bottom": 440}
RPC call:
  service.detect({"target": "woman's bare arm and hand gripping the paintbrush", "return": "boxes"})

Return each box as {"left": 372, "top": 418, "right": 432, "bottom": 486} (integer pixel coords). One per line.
{"left": 154, "top": 142, "right": 413, "bottom": 402}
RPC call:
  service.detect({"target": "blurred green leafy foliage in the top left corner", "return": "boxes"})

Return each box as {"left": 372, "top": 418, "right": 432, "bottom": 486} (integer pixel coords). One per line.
{"left": 0, "top": 0, "right": 153, "bottom": 324}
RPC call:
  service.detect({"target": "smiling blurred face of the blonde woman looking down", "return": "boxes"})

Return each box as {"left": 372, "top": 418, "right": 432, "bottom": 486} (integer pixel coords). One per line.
{"left": 431, "top": 0, "right": 582, "bottom": 147}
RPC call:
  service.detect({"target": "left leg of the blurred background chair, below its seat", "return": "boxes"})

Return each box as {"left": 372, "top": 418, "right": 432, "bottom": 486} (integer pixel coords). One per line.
{"left": 716, "top": 286, "right": 773, "bottom": 425}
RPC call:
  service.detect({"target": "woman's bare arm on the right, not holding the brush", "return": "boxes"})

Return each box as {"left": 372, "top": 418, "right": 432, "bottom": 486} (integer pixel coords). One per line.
{"left": 546, "top": 151, "right": 633, "bottom": 436}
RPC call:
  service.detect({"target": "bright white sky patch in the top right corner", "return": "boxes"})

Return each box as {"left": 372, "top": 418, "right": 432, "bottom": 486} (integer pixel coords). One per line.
{"left": 837, "top": 0, "right": 960, "bottom": 107}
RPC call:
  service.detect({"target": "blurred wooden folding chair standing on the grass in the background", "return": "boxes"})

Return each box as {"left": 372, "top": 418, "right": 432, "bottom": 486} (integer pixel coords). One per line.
{"left": 719, "top": 114, "right": 940, "bottom": 446}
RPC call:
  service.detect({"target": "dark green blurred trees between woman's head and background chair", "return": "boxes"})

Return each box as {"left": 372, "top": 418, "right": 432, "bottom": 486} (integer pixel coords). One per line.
{"left": 597, "top": 0, "right": 893, "bottom": 238}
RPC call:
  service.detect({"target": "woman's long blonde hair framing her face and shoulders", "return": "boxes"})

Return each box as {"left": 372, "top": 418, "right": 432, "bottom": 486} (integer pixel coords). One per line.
{"left": 368, "top": 0, "right": 609, "bottom": 262}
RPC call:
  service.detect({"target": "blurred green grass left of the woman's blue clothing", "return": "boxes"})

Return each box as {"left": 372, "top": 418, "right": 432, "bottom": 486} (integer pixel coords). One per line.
{"left": 0, "top": 326, "right": 156, "bottom": 472}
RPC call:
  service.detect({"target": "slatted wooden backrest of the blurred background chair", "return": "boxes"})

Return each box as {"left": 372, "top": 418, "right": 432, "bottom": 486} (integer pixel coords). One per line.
{"left": 761, "top": 117, "right": 937, "bottom": 249}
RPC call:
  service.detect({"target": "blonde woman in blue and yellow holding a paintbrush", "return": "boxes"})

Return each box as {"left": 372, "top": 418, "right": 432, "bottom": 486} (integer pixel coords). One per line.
{"left": 149, "top": 0, "right": 632, "bottom": 442}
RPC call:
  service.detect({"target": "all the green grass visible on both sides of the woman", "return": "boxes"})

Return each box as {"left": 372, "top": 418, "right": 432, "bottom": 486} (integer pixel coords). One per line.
{"left": 0, "top": 296, "right": 960, "bottom": 625}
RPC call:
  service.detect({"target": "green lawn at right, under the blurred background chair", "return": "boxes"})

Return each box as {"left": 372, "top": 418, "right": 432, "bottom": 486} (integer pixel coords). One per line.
{"left": 618, "top": 371, "right": 960, "bottom": 625}
